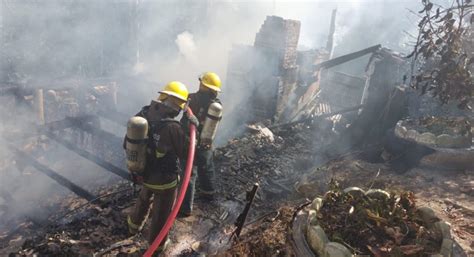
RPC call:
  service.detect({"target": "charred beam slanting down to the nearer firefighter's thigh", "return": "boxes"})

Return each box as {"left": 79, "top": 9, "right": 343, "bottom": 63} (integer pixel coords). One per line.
{"left": 46, "top": 132, "right": 130, "bottom": 180}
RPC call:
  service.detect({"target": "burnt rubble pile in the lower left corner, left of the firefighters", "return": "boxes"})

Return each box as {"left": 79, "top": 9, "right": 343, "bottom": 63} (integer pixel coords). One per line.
{"left": 8, "top": 182, "right": 135, "bottom": 256}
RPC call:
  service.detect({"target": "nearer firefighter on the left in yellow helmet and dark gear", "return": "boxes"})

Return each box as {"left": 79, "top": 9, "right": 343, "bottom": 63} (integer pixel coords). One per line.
{"left": 126, "top": 81, "right": 198, "bottom": 252}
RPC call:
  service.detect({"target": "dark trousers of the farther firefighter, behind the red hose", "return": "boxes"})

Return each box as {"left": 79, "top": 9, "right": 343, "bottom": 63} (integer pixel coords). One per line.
{"left": 180, "top": 148, "right": 215, "bottom": 214}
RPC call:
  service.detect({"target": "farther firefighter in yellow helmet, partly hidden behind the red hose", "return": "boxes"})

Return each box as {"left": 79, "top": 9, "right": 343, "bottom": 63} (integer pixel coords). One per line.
{"left": 179, "top": 72, "right": 222, "bottom": 217}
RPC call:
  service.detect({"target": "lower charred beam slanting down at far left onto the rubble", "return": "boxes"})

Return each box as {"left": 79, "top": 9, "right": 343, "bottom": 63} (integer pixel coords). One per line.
{"left": 8, "top": 140, "right": 97, "bottom": 201}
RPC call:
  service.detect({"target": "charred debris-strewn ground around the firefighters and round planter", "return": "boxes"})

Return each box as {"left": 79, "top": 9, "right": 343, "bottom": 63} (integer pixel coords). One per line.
{"left": 0, "top": 122, "right": 474, "bottom": 256}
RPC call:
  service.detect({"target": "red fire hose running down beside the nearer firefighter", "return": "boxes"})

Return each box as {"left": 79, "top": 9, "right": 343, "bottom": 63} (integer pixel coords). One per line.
{"left": 143, "top": 108, "right": 196, "bottom": 257}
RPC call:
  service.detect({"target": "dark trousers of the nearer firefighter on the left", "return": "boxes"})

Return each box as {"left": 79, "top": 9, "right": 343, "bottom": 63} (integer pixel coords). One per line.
{"left": 128, "top": 186, "right": 177, "bottom": 249}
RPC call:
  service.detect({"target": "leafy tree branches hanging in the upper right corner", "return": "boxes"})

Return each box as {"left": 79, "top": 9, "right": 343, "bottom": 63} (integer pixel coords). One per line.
{"left": 407, "top": 0, "right": 474, "bottom": 109}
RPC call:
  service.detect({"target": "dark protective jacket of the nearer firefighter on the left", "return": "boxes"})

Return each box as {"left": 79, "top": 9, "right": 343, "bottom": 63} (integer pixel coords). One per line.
{"left": 136, "top": 106, "right": 186, "bottom": 190}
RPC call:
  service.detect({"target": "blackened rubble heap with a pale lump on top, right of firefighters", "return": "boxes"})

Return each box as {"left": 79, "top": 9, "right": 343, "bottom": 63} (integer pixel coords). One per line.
{"left": 216, "top": 122, "right": 328, "bottom": 209}
